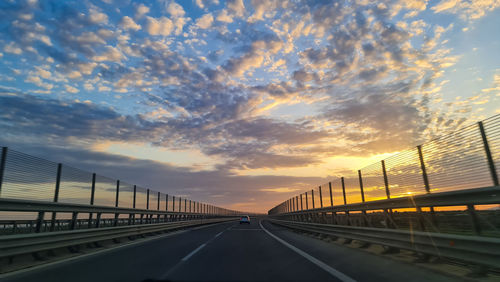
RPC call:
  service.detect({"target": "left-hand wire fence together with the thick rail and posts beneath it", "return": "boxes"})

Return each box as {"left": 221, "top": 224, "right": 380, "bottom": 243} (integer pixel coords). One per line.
{"left": 0, "top": 147, "right": 250, "bottom": 235}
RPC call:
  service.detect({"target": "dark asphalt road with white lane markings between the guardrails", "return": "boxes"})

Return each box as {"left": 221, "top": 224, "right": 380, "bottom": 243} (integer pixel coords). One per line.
{"left": 1, "top": 219, "right": 464, "bottom": 282}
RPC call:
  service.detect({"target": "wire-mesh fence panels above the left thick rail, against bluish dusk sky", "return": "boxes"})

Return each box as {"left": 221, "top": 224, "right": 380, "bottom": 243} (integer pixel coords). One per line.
{"left": 0, "top": 147, "right": 241, "bottom": 219}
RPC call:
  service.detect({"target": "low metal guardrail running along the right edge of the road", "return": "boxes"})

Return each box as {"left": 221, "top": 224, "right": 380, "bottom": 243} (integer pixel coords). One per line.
{"left": 270, "top": 219, "right": 500, "bottom": 269}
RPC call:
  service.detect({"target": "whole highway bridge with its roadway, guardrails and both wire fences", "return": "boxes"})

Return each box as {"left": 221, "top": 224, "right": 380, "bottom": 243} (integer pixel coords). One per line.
{"left": 0, "top": 115, "right": 500, "bottom": 281}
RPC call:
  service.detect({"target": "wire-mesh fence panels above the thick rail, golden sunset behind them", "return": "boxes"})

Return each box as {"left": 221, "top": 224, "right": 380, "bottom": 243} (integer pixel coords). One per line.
{"left": 268, "top": 115, "right": 500, "bottom": 224}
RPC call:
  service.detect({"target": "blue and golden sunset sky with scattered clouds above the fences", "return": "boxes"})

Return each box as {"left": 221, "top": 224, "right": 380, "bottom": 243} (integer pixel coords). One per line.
{"left": 0, "top": 0, "right": 500, "bottom": 212}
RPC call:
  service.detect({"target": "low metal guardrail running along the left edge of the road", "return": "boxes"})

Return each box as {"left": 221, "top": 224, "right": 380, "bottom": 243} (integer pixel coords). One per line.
{"left": 0, "top": 218, "right": 234, "bottom": 258}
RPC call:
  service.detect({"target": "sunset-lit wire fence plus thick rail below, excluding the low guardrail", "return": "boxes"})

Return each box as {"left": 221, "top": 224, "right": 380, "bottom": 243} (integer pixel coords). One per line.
{"left": 268, "top": 115, "right": 500, "bottom": 236}
